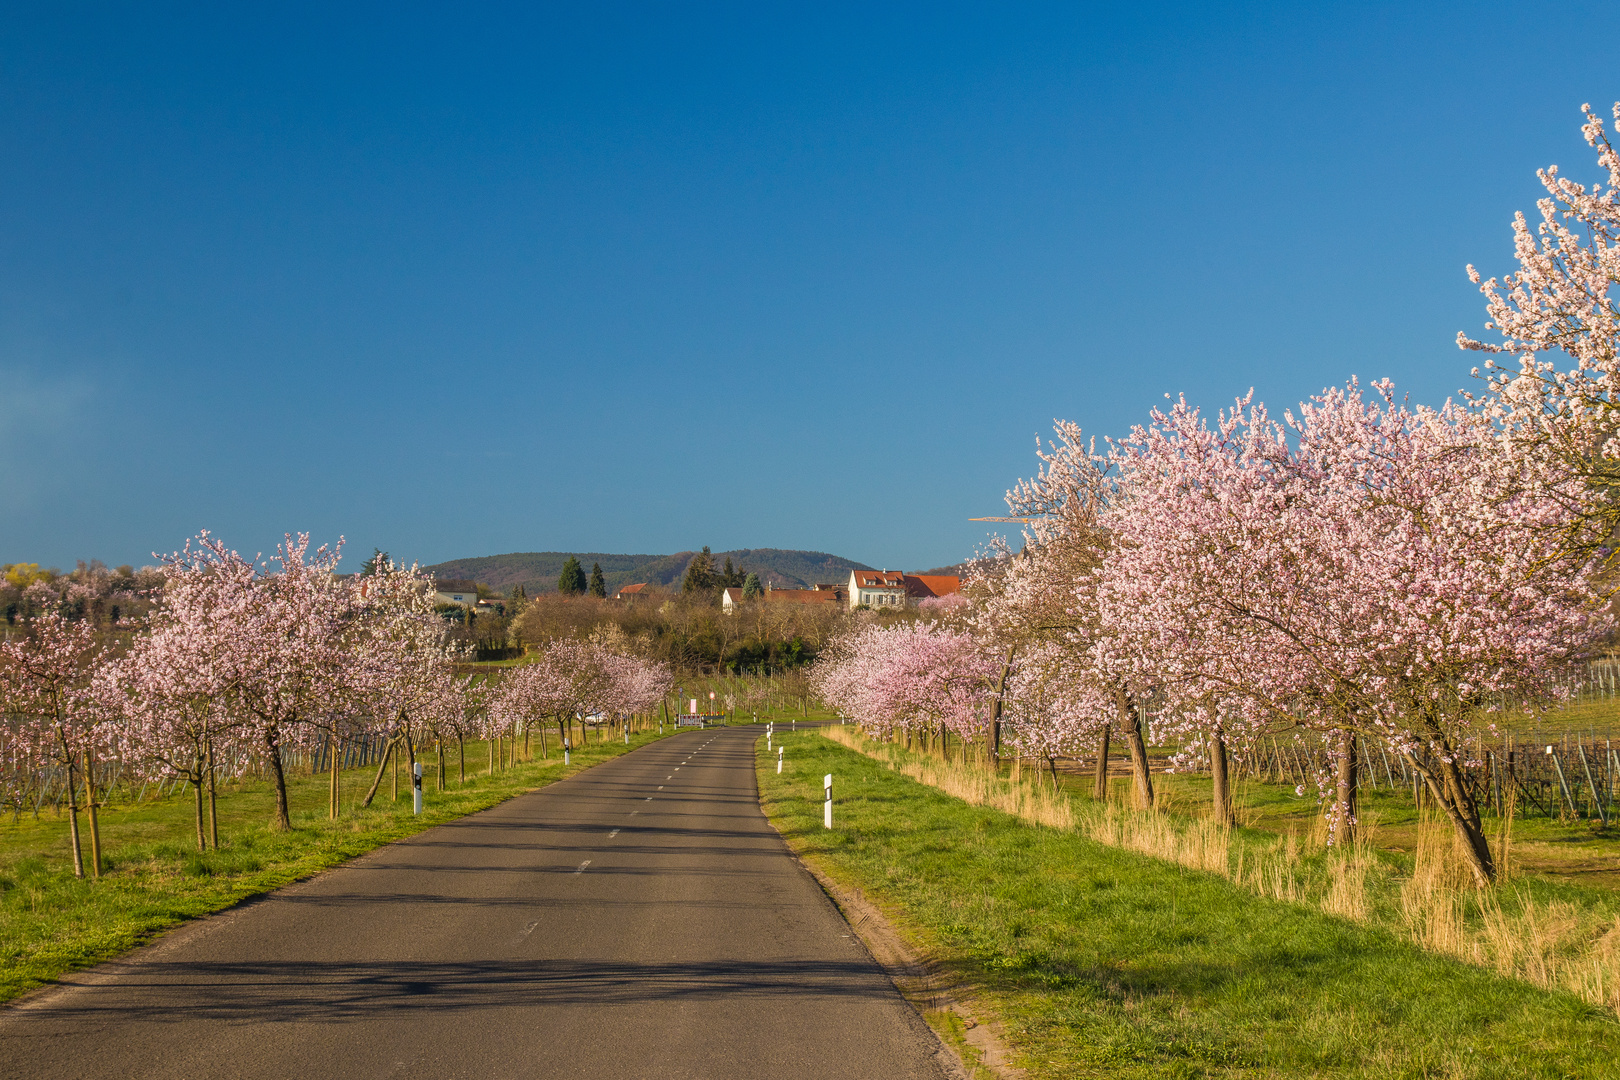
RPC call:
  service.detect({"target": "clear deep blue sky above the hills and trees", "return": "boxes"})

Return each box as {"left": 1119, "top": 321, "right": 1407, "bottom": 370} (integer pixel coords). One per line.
{"left": 0, "top": 3, "right": 1620, "bottom": 568}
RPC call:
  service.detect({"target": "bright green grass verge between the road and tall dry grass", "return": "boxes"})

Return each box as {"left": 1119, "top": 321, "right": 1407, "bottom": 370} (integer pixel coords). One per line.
{"left": 758, "top": 733, "right": 1620, "bottom": 1078}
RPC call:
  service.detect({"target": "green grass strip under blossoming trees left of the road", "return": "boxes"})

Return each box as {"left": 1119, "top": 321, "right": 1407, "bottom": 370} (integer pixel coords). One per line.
{"left": 0, "top": 729, "right": 674, "bottom": 1001}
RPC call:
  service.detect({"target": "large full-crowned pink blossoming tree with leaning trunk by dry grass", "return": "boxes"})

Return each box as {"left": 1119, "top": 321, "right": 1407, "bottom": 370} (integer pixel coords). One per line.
{"left": 1108, "top": 382, "right": 1605, "bottom": 882}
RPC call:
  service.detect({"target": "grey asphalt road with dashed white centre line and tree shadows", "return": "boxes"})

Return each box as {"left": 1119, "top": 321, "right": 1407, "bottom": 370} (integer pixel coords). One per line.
{"left": 0, "top": 727, "right": 949, "bottom": 1080}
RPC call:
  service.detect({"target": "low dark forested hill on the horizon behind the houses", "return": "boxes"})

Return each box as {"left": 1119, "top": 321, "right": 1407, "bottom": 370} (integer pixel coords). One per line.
{"left": 426, "top": 547, "right": 873, "bottom": 596}
